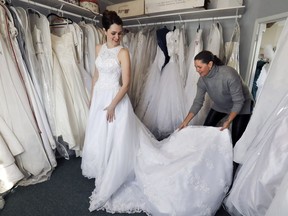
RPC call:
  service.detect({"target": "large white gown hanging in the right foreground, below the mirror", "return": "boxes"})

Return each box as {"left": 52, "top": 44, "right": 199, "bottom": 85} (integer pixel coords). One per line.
{"left": 225, "top": 21, "right": 288, "bottom": 216}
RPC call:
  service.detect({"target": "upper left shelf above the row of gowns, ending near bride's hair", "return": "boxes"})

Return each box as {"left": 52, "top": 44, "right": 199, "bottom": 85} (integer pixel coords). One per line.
{"left": 12, "top": 0, "right": 100, "bottom": 20}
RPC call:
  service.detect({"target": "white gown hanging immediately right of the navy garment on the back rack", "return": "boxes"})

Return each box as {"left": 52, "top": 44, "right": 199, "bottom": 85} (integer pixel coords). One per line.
{"left": 152, "top": 29, "right": 187, "bottom": 138}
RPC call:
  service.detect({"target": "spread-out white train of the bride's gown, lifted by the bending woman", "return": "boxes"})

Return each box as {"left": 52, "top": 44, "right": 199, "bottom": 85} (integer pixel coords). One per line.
{"left": 90, "top": 121, "right": 232, "bottom": 216}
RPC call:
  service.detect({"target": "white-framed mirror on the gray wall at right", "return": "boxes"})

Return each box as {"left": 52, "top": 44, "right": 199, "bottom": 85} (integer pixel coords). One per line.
{"left": 247, "top": 13, "right": 288, "bottom": 101}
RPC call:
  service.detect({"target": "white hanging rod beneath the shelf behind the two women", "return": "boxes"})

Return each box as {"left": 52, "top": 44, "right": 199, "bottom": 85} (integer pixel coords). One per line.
{"left": 123, "top": 15, "right": 242, "bottom": 28}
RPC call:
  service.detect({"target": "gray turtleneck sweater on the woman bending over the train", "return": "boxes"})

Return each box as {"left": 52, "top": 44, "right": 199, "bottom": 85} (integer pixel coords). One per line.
{"left": 189, "top": 65, "right": 253, "bottom": 115}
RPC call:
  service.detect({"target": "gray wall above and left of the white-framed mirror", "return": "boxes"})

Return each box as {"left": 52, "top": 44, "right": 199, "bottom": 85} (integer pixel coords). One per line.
{"left": 239, "top": 0, "right": 288, "bottom": 79}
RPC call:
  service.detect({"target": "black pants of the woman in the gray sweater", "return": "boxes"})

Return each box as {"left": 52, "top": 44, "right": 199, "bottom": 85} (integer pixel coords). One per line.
{"left": 204, "top": 109, "right": 251, "bottom": 147}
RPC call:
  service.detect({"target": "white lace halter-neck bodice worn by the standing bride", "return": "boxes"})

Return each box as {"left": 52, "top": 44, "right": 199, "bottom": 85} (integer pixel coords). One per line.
{"left": 95, "top": 43, "right": 122, "bottom": 89}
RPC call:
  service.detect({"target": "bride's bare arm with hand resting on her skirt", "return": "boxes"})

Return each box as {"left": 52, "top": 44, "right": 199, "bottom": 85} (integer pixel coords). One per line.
{"left": 105, "top": 48, "right": 131, "bottom": 122}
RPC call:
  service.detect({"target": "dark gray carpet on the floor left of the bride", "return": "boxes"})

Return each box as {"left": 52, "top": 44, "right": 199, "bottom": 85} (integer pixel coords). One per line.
{"left": 0, "top": 156, "right": 229, "bottom": 216}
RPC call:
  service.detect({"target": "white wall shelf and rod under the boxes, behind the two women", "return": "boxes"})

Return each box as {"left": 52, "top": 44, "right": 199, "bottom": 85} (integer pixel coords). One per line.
{"left": 123, "top": 6, "right": 245, "bottom": 27}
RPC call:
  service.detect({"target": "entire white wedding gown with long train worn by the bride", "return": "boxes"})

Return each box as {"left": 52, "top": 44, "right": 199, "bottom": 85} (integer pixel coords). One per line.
{"left": 81, "top": 44, "right": 232, "bottom": 216}
